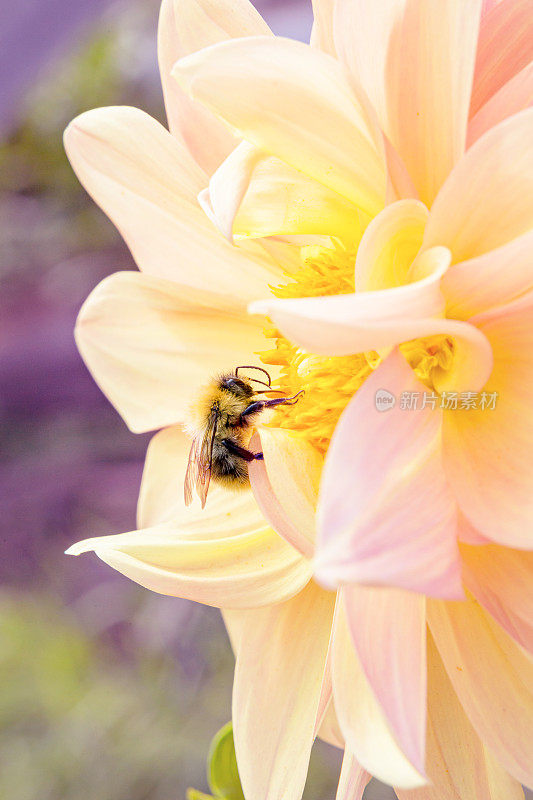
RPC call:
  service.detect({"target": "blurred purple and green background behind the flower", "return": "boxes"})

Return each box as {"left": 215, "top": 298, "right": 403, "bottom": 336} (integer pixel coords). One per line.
{"left": 0, "top": 0, "right": 448, "bottom": 800}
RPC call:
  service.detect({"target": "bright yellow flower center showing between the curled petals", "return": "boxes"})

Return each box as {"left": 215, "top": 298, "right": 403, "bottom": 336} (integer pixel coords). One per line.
{"left": 259, "top": 240, "right": 453, "bottom": 453}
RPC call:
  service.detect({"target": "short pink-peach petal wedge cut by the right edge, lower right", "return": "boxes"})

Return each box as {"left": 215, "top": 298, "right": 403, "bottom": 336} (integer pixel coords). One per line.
{"left": 461, "top": 544, "right": 533, "bottom": 653}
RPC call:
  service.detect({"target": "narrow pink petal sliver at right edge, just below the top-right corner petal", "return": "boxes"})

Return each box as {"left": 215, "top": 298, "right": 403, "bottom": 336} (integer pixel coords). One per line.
{"left": 466, "top": 63, "right": 533, "bottom": 147}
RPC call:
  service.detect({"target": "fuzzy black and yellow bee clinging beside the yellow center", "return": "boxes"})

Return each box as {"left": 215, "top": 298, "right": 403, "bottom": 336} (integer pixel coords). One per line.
{"left": 184, "top": 366, "right": 303, "bottom": 508}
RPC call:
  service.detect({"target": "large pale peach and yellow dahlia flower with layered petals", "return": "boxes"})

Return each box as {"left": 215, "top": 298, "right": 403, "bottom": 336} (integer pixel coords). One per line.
{"left": 65, "top": 0, "right": 533, "bottom": 800}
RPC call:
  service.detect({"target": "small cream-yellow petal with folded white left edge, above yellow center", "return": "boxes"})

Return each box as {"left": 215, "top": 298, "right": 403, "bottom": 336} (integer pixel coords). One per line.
{"left": 208, "top": 142, "right": 360, "bottom": 241}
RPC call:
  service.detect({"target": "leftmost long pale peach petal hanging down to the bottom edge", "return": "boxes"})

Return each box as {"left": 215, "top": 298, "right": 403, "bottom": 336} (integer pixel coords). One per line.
{"left": 233, "top": 583, "right": 335, "bottom": 800}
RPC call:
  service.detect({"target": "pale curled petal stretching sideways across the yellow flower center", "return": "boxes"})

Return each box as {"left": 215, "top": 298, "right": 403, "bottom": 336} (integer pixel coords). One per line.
{"left": 249, "top": 260, "right": 492, "bottom": 391}
